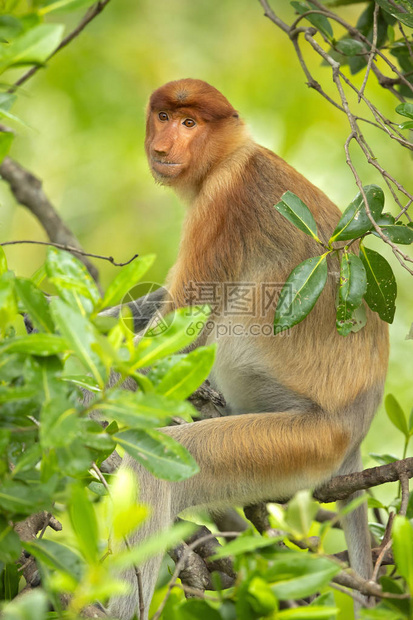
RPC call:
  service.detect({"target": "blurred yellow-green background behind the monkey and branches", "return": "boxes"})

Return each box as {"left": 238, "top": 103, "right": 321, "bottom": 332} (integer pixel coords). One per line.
{"left": 0, "top": 0, "right": 413, "bottom": 482}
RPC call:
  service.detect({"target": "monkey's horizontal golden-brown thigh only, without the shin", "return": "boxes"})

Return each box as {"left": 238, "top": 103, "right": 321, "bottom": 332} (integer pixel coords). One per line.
{"left": 162, "top": 410, "right": 350, "bottom": 513}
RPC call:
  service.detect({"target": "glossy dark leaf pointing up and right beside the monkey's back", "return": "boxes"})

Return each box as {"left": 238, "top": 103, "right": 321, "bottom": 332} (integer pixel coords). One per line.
{"left": 330, "top": 185, "right": 384, "bottom": 243}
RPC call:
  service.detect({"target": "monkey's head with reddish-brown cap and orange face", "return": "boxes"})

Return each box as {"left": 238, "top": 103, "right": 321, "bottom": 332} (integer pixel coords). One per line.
{"left": 145, "top": 79, "right": 246, "bottom": 196}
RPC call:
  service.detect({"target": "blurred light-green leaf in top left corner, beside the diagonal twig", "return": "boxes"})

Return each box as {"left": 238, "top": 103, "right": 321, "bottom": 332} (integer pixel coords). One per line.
{"left": 0, "top": 24, "right": 64, "bottom": 70}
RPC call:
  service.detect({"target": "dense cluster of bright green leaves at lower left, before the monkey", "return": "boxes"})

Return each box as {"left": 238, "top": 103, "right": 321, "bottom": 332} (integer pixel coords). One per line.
{"left": 0, "top": 248, "right": 215, "bottom": 618}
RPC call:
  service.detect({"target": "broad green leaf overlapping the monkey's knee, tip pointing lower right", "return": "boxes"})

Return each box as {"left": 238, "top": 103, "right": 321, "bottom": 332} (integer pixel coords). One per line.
{"left": 113, "top": 430, "right": 199, "bottom": 481}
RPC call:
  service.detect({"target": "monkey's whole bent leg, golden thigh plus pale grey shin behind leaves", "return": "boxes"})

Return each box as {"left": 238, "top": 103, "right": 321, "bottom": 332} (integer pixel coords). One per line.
{"left": 109, "top": 410, "right": 350, "bottom": 620}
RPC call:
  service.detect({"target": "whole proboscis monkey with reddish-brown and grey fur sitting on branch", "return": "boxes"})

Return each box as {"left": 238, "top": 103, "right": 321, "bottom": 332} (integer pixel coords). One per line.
{"left": 110, "top": 79, "right": 388, "bottom": 620}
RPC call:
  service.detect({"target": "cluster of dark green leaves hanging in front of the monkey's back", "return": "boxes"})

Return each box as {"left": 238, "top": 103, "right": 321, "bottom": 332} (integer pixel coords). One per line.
{"left": 274, "top": 184, "right": 413, "bottom": 336}
